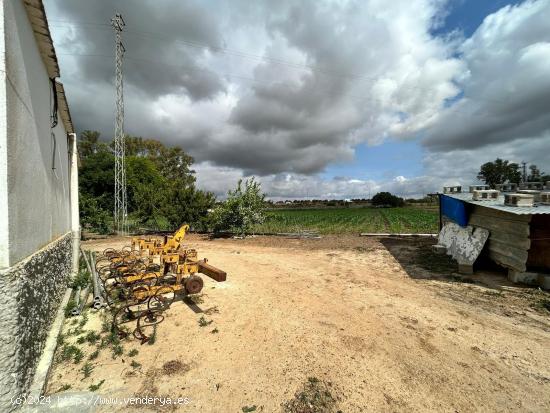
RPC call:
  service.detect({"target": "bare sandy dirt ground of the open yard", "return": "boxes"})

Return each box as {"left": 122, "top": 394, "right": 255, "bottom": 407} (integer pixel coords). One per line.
{"left": 48, "top": 235, "right": 550, "bottom": 413}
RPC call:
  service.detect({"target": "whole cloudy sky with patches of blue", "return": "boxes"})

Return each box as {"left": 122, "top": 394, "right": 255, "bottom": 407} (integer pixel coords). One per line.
{"left": 44, "top": 0, "right": 550, "bottom": 200}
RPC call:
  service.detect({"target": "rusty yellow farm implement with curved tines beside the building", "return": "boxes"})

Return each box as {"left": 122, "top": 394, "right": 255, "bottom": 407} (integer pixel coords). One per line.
{"left": 95, "top": 225, "right": 226, "bottom": 342}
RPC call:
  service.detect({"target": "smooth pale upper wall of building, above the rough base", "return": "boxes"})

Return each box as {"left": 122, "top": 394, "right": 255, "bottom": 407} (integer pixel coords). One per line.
{"left": 3, "top": 0, "right": 70, "bottom": 266}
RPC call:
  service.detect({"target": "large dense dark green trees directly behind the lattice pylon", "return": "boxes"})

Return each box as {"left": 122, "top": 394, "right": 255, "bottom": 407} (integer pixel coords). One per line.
{"left": 79, "top": 131, "right": 215, "bottom": 232}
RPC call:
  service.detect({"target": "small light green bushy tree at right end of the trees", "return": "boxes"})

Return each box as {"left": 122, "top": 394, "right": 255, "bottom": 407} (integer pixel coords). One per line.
{"left": 212, "top": 177, "right": 265, "bottom": 235}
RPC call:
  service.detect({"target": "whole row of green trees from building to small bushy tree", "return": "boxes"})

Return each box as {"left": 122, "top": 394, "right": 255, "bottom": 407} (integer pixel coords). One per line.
{"left": 78, "top": 131, "right": 265, "bottom": 233}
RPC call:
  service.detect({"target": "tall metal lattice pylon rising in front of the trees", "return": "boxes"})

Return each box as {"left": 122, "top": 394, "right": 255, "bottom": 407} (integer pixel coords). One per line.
{"left": 111, "top": 13, "right": 128, "bottom": 235}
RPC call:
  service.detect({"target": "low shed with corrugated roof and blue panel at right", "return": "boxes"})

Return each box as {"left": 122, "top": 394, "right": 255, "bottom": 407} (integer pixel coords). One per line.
{"left": 439, "top": 193, "right": 550, "bottom": 288}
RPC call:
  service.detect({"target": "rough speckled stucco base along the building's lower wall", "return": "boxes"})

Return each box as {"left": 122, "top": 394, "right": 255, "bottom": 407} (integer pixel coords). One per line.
{"left": 0, "top": 233, "right": 72, "bottom": 411}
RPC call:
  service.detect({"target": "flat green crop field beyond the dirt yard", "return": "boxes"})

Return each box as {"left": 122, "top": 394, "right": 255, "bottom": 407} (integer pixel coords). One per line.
{"left": 255, "top": 207, "right": 439, "bottom": 234}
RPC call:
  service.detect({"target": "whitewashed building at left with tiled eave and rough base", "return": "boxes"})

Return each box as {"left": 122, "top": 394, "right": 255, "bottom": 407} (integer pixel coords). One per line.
{"left": 0, "top": 0, "right": 79, "bottom": 411}
